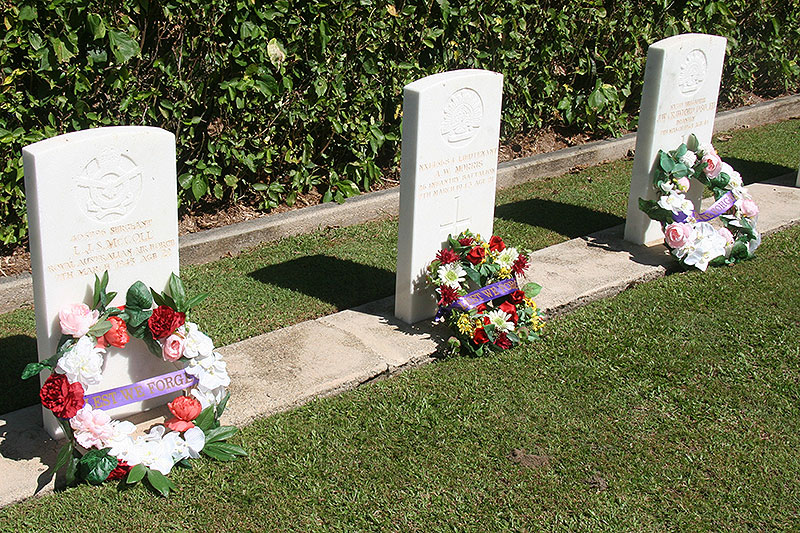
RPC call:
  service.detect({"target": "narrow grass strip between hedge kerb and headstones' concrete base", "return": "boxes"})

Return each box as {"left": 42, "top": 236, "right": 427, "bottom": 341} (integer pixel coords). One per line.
{"left": 0, "top": 120, "right": 800, "bottom": 413}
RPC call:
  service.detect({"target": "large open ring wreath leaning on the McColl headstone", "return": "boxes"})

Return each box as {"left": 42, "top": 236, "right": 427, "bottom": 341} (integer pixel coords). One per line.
{"left": 22, "top": 272, "right": 247, "bottom": 496}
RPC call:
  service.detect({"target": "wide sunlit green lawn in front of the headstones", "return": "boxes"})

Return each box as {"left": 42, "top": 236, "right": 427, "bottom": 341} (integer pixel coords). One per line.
{"left": 0, "top": 216, "right": 800, "bottom": 532}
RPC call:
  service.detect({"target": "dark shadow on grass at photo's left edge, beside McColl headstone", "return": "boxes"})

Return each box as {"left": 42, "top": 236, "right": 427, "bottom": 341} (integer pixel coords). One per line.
{"left": 0, "top": 335, "right": 39, "bottom": 413}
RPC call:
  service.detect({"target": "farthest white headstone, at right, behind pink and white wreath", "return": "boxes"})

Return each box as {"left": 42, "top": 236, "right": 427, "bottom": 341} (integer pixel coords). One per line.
{"left": 625, "top": 33, "right": 726, "bottom": 244}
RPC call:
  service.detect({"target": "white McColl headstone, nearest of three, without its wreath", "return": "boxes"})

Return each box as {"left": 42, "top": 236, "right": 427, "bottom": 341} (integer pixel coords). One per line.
{"left": 22, "top": 126, "right": 178, "bottom": 436}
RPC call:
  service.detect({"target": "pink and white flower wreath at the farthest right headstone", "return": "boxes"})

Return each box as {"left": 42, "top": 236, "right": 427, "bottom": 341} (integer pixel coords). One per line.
{"left": 639, "top": 134, "right": 761, "bottom": 271}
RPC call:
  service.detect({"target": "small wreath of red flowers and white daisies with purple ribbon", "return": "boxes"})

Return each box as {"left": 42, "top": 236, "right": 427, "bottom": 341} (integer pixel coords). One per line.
{"left": 427, "top": 230, "right": 544, "bottom": 356}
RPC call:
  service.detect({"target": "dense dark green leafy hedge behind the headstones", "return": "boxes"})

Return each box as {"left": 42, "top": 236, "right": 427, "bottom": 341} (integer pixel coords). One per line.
{"left": 0, "top": 0, "right": 800, "bottom": 243}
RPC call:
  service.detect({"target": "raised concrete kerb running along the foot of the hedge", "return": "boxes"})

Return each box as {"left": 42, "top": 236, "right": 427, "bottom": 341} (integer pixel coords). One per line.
{"left": 0, "top": 95, "right": 800, "bottom": 313}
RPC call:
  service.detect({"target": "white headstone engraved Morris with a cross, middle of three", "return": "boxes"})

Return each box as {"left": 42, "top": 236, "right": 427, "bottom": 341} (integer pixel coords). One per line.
{"left": 395, "top": 70, "right": 503, "bottom": 324}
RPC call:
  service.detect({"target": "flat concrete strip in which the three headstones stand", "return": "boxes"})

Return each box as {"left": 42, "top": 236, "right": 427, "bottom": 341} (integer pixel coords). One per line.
{"left": 0, "top": 174, "right": 800, "bottom": 505}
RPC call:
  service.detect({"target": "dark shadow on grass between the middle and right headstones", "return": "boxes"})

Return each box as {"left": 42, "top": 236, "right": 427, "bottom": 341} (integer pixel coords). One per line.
{"left": 494, "top": 198, "right": 625, "bottom": 239}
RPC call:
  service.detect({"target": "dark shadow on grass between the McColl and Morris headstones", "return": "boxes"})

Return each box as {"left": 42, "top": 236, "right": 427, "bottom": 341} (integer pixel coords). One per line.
{"left": 248, "top": 254, "right": 394, "bottom": 310}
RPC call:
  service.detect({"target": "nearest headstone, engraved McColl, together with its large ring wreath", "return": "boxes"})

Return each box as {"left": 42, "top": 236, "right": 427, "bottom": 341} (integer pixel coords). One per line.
{"left": 22, "top": 127, "right": 246, "bottom": 496}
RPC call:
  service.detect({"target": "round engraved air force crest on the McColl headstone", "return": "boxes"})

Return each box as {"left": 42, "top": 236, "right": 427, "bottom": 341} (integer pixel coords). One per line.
{"left": 75, "top": 150, "right": 142, "bottom": 222}
